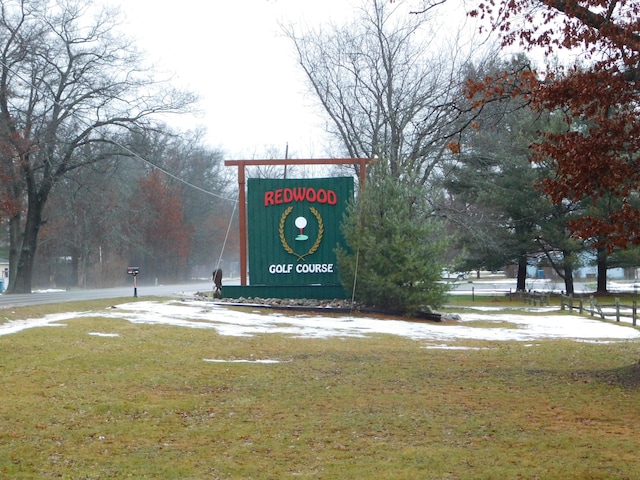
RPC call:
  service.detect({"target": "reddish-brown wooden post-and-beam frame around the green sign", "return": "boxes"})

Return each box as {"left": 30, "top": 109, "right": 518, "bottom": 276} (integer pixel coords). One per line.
{"left": 224, "top": 158, "right": 371, "bottom": 285}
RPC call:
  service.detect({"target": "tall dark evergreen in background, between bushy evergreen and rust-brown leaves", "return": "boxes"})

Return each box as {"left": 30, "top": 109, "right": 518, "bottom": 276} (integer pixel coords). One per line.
{"left": 444, "top": 55, "right": 582, "bottom": 293}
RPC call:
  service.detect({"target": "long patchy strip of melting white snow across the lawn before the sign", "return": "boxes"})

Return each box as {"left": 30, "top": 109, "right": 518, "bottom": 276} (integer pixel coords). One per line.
{"left": 0, "top": 301, "right": 640, "bottom": 348}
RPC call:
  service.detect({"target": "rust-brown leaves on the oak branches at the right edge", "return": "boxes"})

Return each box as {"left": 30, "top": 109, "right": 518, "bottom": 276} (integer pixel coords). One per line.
{"left": 467, "top": 0, "right": 640, "bottom": 248}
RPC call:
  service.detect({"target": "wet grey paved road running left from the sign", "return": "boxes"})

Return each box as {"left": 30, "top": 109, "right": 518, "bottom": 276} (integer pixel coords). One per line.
{"left": 0, "top": 282, "right": 212, "bottom": 308}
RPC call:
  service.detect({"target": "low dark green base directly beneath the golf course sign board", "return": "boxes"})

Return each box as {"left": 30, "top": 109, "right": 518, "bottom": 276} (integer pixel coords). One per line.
{"left": 222, "top": 285, "right": 349, "bottom": 300}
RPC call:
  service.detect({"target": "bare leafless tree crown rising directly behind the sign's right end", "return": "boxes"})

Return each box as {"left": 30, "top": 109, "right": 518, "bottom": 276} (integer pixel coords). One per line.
{"left": 283, "top": 0, "right": 476, "bottom": 184}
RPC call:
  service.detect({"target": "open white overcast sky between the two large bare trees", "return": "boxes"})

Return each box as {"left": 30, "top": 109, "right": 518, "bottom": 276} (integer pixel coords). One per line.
{"left": 108, "top": 0, "right": 364, "bottom": 158}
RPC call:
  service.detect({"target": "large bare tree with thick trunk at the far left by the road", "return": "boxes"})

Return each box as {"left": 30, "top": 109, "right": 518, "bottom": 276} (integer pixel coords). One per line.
{"left": 0, "top": 0, "right": 195, "bottom": 293}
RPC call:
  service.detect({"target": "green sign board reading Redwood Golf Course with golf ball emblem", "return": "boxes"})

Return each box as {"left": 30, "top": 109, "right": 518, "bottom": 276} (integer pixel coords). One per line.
{"left": 247, "top": 177, "right": 353, "bottom": 285}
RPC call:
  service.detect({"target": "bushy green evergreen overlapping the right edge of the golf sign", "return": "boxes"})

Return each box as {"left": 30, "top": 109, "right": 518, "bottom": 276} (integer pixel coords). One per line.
{"left": 337, "top": 166, "right": 448, "bottom": 315}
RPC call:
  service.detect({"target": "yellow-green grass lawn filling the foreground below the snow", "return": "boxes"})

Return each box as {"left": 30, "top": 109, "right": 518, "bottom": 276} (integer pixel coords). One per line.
{"left": 0, "top": 299, "right": 640, "bottom": 480}
